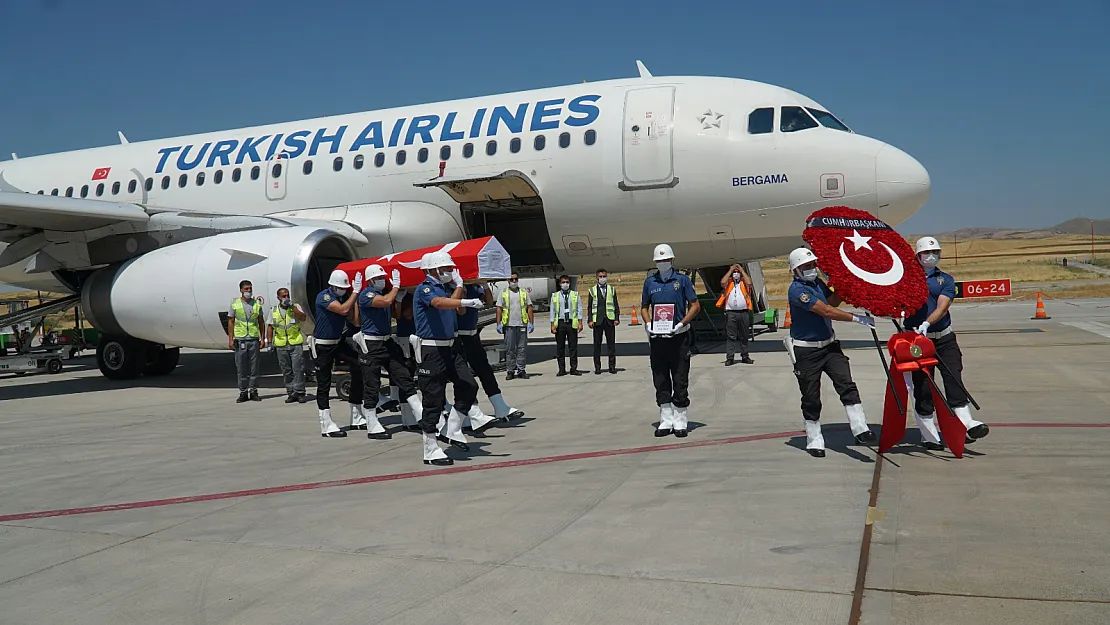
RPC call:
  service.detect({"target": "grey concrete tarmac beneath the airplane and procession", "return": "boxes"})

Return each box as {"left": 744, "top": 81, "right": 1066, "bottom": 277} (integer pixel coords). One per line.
{"left": 0, "top": 300, "right": 1110, "bottom": 625}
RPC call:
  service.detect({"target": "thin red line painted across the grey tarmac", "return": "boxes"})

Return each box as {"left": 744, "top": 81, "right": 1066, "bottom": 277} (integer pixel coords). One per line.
{"left": 0, "top": 423, "right": 1110, "bottom": 523}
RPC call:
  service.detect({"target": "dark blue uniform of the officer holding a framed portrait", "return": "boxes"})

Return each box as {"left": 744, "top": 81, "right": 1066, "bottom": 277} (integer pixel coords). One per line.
{"left": 639, "top": 270, "right": 697, "bottom": 407}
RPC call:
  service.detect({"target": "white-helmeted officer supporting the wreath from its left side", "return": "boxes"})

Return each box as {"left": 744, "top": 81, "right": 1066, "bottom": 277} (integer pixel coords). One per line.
{"left": 785, "top": 248, "right": 876, "bottom": 457}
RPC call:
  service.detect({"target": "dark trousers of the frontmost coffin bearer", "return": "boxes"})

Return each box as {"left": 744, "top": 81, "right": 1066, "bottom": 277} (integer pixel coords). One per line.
{"left": 416, "top": 343, "right": 478, "bottom": 434}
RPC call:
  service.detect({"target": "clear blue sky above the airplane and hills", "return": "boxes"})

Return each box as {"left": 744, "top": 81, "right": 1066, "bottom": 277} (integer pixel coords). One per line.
{"left": 0, "top": 0, "right": 1110, "bottom": 232}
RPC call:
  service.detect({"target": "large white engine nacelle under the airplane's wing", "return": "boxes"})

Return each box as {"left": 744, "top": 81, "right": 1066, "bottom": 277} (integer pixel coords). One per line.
{"left": 81, "top": 226, "right": 356, "bottom": 349}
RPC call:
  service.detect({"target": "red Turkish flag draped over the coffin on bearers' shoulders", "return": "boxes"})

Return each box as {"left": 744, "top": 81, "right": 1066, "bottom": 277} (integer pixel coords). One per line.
{"left": 336, "top": 236, "right": 513, "bottom": 289}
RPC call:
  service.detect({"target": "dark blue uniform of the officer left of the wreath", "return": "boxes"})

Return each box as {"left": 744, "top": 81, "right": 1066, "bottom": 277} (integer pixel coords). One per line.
{"left": 787, "top": 278, "right": 860, "bottom": 421}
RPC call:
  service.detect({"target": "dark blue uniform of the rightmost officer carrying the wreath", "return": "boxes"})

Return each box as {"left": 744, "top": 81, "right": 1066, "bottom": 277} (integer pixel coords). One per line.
{"left": 906, "top": 266, "right": 970, "bottom": 415}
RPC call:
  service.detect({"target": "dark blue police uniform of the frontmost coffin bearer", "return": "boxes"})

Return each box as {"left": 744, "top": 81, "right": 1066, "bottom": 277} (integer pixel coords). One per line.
{"left": 413, "top": 278, "right": 478, "bottom": 437}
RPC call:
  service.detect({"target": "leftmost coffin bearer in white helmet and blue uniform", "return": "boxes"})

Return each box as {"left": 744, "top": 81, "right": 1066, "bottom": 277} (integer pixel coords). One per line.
{"left": 311, "top": 269, "right": 365, "bottom": 438}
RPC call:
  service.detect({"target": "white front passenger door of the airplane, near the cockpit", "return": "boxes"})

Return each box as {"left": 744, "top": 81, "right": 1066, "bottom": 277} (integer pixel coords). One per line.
{"left": 619, "top": 85, "right": 678, "bottom": 191}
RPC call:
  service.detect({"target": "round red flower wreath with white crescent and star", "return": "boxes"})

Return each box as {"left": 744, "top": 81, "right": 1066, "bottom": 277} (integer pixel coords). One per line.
{"left": 801, "top": 206, "right": 929, "bottom": 317}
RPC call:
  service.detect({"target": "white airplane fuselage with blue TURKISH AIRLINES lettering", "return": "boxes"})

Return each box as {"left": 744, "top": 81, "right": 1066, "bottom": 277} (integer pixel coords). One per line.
{"left": 0, "top": 77, "right": 929, "bottom": 290}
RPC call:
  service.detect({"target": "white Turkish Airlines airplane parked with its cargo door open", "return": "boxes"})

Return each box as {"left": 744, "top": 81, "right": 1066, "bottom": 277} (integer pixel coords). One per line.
{"left": 0, "top": 61, "right": 930, "bottom": 380}
